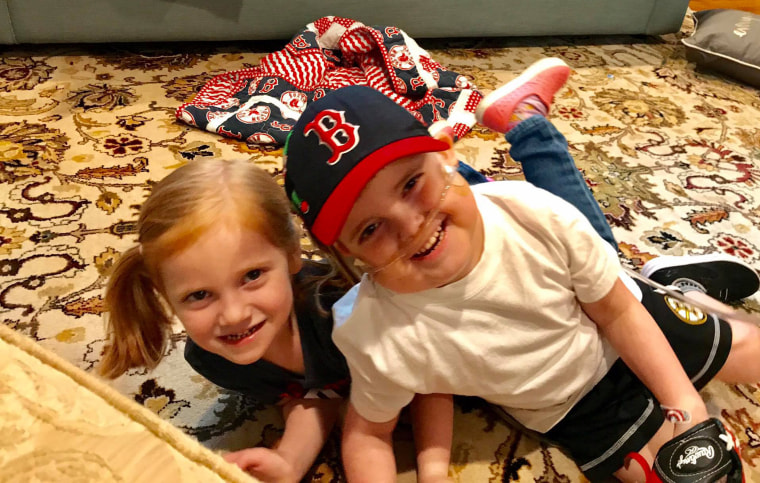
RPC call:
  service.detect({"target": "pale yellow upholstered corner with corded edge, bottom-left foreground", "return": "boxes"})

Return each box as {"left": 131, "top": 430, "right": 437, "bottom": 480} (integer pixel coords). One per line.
{"left": 0, "top": 325, "right": 252, "bottom": 483}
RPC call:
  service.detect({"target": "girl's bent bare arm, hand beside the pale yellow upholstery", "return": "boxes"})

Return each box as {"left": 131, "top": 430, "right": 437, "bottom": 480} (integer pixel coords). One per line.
{"left": 224, "top": 399, "right": 343, "bottom": 483}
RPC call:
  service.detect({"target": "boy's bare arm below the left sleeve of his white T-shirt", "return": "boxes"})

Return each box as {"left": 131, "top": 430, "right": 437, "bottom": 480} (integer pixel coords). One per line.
{"left": 342, "top": 403, "right": 398, "bottom": 483}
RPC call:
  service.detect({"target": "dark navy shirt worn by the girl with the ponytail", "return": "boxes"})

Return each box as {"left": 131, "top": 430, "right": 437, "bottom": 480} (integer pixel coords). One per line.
{"left": 185, "top": 264, "right": 349, "bottom": 404}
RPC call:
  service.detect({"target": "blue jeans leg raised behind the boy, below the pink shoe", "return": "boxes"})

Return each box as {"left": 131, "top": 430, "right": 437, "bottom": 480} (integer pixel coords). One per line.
{"left": 505, "top": 116, "right": 618, "bottom": 248}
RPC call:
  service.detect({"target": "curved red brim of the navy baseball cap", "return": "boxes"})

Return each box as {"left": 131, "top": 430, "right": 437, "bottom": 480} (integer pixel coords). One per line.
{"left": 311, "top": 136, "right": 449, "bottom": 246}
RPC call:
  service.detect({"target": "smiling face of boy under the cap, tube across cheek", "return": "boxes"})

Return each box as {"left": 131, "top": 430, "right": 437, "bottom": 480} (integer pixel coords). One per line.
{"left": 336, "top": 149, "right": 483, "bottom": 293}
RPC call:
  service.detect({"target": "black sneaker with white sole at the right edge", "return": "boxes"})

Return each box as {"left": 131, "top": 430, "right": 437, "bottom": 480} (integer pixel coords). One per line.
{"left": 641, "top": 253, "right": 760, "bottom": 302}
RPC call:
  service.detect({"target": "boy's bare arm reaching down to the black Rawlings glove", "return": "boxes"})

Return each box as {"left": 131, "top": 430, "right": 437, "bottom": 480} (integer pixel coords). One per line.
{"left": 581, "top": 279, "right": 708, "bottom": 431}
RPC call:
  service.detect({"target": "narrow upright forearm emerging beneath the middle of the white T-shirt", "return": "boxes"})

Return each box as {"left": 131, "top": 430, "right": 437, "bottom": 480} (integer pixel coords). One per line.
{"left": 411, "top": 394, "right": 454, "bottom": 483}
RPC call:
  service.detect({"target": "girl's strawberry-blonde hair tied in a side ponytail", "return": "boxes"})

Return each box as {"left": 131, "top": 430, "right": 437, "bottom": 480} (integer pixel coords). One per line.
{"left": 99, "top": 160, "right": 301, "bottom": 378}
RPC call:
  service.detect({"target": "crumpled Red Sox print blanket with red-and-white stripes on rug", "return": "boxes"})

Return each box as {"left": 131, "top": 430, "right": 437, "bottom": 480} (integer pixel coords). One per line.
{"left": 176, "top": 17, "right": 482, "bottom": 145}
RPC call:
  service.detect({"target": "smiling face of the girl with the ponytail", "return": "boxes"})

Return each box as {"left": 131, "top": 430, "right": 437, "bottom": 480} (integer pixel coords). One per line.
{"left": 159, "top": 222, "right": 301, "bottom": 364}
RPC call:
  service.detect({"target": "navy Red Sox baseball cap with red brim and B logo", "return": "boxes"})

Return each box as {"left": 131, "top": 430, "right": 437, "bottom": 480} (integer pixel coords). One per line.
{"left": 284, "top": 86, "right": 449, "bottom": 246}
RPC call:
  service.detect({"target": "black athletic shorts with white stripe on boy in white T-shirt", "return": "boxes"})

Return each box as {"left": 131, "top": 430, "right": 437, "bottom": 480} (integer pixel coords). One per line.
{"left": 545, "top": 281, "right": 731, "bottom": 481}
